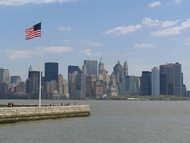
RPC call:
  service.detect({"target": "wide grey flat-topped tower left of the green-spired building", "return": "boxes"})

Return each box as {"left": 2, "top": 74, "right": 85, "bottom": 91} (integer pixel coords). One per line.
{"left": 84, "top": 60, "right": 98, "bottom": 77}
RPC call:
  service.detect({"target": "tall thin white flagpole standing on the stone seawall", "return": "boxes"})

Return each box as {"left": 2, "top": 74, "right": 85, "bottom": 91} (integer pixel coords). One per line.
{"left": 39, "top": 21, "right": 42, "bottom": 107}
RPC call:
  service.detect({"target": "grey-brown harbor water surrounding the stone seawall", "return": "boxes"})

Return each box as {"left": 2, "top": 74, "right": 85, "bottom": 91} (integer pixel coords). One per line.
{"left": 0, "top": 100, "right": 190, "bottom": 143}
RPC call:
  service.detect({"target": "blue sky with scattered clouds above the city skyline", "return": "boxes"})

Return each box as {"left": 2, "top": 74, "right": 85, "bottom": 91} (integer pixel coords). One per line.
{"left": 0, "top": 0, "right": 190, "bottom": 89}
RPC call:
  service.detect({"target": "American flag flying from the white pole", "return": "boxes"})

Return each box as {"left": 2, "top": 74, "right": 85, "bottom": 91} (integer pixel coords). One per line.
{"left": 25, "top": 22, "right": 41, "bottom": 40}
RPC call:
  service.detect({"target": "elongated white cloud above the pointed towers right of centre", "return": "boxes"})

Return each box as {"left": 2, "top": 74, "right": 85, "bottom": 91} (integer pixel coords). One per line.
{"left": 105, "top": 24, "right": 142, "bottom": 35}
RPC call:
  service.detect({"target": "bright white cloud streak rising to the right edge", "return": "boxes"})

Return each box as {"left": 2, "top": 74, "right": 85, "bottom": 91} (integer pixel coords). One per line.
{"left": 151, "top": 19, "right": 190, "bottom": 36}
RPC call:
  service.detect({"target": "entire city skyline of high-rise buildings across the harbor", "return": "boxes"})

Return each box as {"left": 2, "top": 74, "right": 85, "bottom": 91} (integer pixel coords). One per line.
{"left": 0, "top": 59, "right": 189, "bottom": 99}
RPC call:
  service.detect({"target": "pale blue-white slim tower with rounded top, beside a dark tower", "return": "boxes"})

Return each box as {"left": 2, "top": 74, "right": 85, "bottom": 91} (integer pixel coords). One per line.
{"left": 151, "top": 67, "right": 160, "bottom": 95}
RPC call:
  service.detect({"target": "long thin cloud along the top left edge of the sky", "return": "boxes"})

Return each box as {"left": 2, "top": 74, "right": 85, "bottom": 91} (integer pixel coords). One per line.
{"left": 0, "top": 0, "right": 78, "bottom": 6}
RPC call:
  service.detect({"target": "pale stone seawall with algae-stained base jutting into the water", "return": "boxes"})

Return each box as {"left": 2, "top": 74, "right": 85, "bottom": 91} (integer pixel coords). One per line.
{"left": 0, "top": 105, "right": 90, "bottom": 124}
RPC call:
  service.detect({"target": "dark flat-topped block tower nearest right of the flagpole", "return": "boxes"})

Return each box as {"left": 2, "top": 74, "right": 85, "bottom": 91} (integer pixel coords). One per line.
{"left": 45, "top": 62, "right": 58, "bottom": 82}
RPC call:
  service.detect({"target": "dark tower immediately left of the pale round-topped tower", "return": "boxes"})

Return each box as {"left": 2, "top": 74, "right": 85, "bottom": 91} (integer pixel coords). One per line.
{"left": 141, "top": 71, "right": 151, "bottom": 95}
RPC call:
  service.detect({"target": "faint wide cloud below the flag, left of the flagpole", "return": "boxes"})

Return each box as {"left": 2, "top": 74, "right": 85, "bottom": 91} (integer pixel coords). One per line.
{"left": 2, "top": 49, "right": 39, "bottom": 60}
